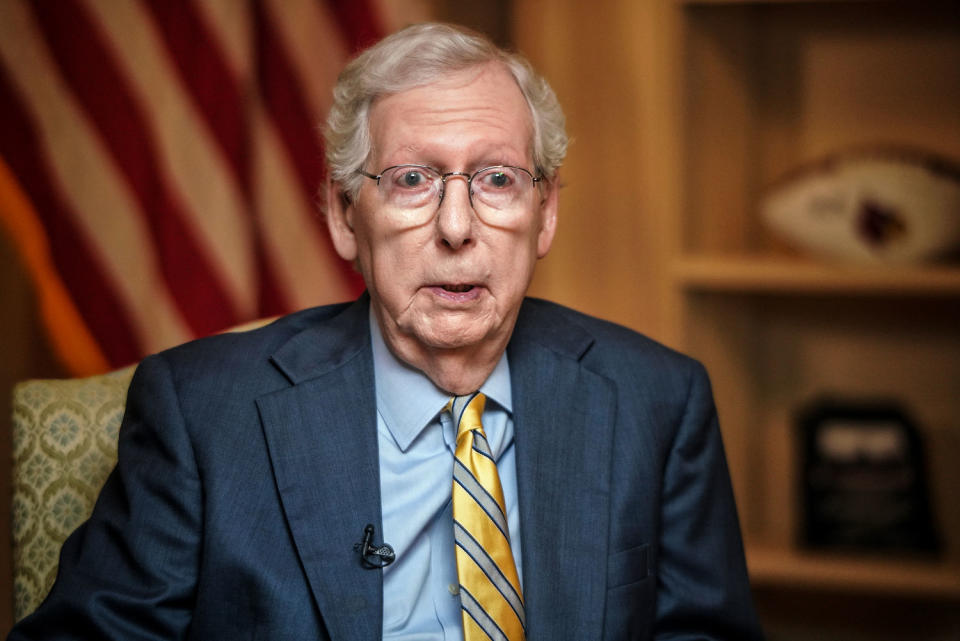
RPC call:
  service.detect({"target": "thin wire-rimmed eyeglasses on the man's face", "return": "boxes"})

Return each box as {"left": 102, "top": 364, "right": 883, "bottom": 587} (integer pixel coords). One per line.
{"left": 357, "top": 164, "right": 543, "bottom": 225}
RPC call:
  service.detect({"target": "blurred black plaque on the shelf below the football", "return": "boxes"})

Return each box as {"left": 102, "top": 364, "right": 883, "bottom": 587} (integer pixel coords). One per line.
{"left": 798, "top": 398, "right": 939, "bottom": 555}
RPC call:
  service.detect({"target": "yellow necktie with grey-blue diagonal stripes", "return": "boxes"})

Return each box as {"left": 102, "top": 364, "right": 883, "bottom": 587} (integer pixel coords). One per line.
{"left": 446, "top": 392, "right": 526, "bottom": 641}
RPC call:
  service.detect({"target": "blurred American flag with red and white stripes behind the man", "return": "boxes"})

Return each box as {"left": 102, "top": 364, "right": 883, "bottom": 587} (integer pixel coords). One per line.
{"left": 0, "top": 0, "right": 381, "bottom": 375}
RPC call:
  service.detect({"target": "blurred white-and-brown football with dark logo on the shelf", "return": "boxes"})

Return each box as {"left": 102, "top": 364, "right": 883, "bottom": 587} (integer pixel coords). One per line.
{"left": 760, "top": 148, "right": 960, "bottom": 263}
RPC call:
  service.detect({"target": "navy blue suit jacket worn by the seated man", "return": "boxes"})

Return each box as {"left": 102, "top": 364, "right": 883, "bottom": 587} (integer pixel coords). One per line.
{"left": 10, "top": 296, "right": 759, "bottom": 641}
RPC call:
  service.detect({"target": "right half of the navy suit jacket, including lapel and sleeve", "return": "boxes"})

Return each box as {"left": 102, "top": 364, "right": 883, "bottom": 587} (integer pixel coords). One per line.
{"left": 508, "top": 299, "right": 759, "bottom": 640}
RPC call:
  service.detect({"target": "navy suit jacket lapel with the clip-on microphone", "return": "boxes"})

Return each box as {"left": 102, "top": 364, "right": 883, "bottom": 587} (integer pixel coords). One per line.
{"left": 257, "top": 298, "right": 383, "bottom": 641}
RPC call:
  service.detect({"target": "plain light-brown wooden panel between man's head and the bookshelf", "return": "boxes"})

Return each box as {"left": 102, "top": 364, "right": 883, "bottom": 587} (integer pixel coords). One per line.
{"left": 512, "top": 0, "right": 672, "bottom": 336}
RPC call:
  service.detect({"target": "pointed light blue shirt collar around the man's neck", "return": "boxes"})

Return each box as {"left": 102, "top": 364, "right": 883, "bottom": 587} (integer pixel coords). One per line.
{"left": 370, "top": 306, "right": 513, "bottom": 451}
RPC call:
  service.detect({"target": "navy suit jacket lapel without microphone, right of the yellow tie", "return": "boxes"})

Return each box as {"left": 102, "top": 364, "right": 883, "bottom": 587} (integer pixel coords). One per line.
{"left": 509, "top": 305, "right": 616, "bottom": 641}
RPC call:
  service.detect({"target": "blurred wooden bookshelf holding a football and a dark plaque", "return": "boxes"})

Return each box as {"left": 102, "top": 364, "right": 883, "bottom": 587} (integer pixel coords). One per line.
{"left": 661, "top": 0, "right": 960, "bottom": 639}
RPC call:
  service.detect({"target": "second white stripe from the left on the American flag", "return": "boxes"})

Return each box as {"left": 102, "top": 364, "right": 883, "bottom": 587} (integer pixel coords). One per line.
{"left": 88, "top": 0, "right": 257, "bottom": 317}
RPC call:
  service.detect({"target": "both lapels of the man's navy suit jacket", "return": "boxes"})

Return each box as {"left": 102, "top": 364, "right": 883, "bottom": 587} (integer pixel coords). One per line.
{"left": 251, "top": 297, "right": 616, "bottom": 641}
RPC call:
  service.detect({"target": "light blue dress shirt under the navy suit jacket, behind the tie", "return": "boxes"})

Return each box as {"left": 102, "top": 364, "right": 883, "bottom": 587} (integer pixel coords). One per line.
{"left": 370, "top": 311, "right": 523, "bottom": 641}
